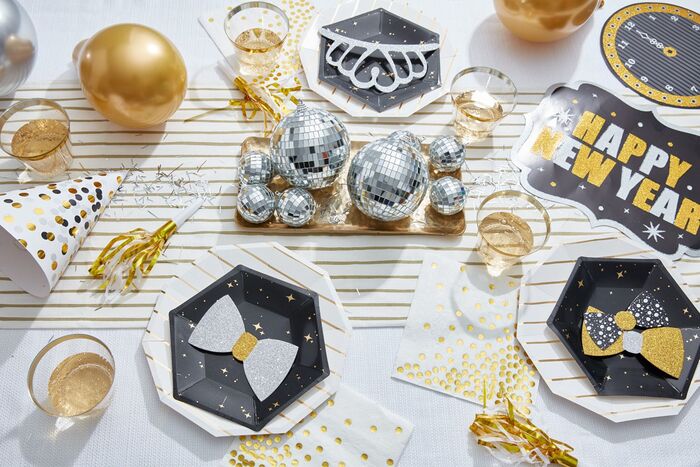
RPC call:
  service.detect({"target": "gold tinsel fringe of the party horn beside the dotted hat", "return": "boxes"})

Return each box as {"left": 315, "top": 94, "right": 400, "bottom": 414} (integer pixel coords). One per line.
{"left": 89, "top": 220, "right": 177, "bottom": 291}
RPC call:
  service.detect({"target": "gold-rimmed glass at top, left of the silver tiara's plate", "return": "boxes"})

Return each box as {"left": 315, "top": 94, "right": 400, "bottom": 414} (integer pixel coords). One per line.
{"left": 224, "top": 2, "right": 289, "bottom": 76}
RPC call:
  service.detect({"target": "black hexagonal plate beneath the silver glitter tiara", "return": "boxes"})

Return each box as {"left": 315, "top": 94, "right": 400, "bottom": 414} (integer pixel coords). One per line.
{"left": 318, "top": 8, "right": 441, "bottom": 112}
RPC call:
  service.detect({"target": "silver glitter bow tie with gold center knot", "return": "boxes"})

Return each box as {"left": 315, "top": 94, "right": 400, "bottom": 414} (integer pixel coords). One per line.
{"left": 187, "top": 295, "right": 299, "bottom": 401}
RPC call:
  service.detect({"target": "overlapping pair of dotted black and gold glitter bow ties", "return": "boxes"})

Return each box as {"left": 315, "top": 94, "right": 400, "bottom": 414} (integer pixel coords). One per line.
{"left": 581, "top": 291, "right": 684, "bottom": 378}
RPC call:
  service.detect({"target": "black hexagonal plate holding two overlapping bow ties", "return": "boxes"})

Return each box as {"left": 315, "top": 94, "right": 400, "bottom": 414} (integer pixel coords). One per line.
{"left": 547, "top": 257, "right": 700, "bottom": 399}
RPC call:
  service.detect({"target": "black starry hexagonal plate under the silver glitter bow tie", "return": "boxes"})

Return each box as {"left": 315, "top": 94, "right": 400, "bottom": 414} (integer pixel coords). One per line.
{"left": 170, "top": 265, "right": 329, "bottom": 431}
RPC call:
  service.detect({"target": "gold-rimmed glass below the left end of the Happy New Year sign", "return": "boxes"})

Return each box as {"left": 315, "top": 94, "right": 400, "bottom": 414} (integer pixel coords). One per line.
{"left": 476, "top": 190, "right": 551, "bottom": 276}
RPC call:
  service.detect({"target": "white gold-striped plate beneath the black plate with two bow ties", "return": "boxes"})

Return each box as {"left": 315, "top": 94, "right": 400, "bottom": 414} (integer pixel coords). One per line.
{"left": 518, "top": 237, "right": 700, "bottom": 422}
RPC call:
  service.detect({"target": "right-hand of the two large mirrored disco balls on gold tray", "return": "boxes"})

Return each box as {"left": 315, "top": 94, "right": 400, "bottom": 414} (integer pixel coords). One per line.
{"left": 348, "top": 139, "right": 428, "bottom": 222}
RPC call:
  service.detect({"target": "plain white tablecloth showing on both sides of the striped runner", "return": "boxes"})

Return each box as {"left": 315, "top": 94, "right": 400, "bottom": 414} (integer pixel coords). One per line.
{"left": 0, "top": 0, "right": 700, "bottom": 467}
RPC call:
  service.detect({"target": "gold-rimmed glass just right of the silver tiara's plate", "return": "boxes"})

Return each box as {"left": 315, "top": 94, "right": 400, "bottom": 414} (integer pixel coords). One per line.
{"left": 450, "top": 67, "right": 518, "bottom": 144}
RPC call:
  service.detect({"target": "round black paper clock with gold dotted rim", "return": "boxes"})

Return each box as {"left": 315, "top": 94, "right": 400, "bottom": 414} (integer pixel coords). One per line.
{"left": 601, "top": 3, "right": 700, "bottom": 108}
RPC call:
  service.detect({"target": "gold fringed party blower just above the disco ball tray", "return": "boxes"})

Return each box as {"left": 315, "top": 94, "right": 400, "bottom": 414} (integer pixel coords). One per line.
{"left": 185, "top": 76, "right": 301, "bottom": 135}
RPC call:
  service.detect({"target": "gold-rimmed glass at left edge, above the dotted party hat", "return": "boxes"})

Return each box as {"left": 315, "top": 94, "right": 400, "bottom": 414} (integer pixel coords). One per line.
{"left": 0, "top": 99, "right": 73, "bottom": 179}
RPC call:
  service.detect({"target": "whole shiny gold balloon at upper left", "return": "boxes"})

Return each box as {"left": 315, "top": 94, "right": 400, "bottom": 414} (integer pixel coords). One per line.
{"left": 73, "top": 24, "right": 187, "bottom": 128}
